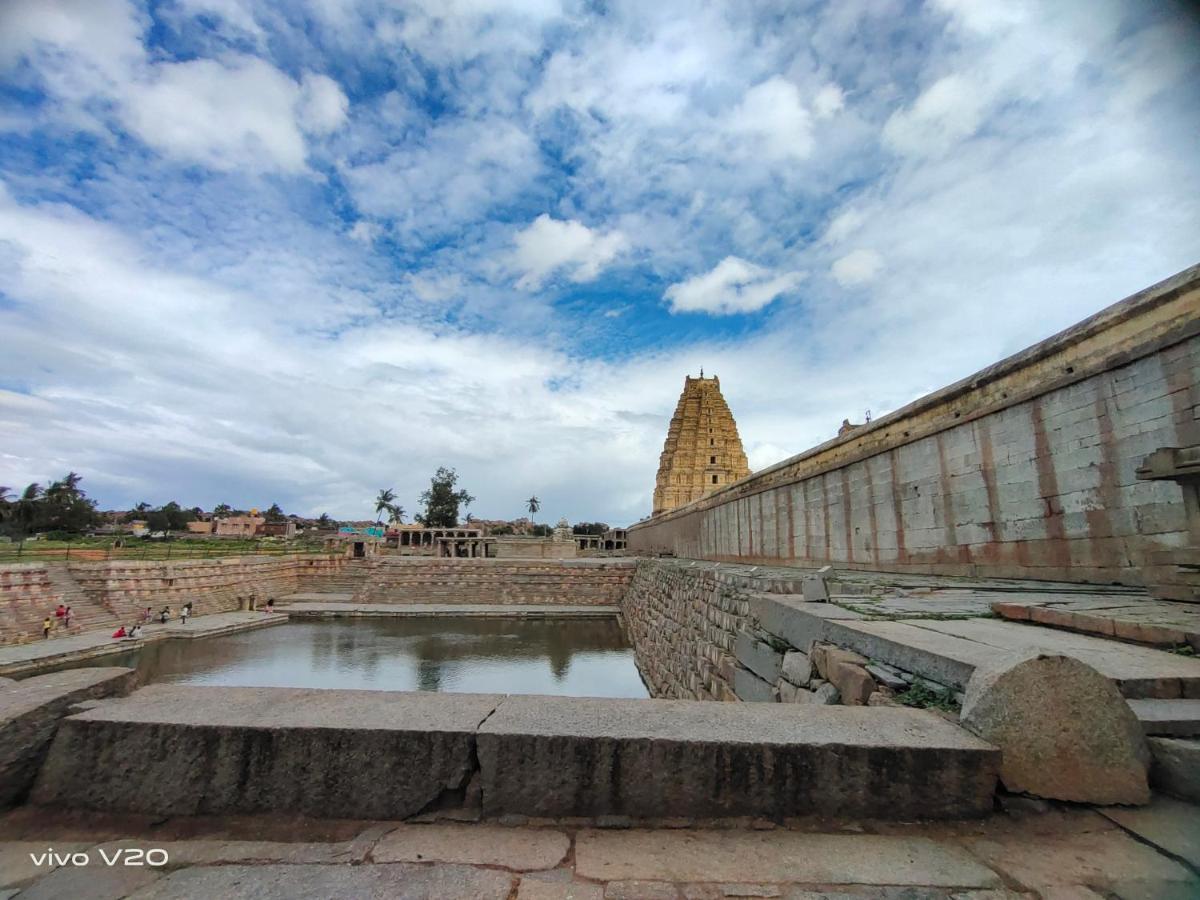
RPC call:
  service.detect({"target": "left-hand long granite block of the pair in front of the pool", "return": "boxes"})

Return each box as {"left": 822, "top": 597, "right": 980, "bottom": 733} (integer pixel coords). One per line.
{"left": 31, "top": 684, "right": 502, "bottom": 818}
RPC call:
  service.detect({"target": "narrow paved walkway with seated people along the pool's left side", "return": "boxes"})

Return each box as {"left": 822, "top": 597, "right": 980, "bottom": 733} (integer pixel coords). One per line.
{"left": 0, "top": 612, "right": 287, "bottom": 676}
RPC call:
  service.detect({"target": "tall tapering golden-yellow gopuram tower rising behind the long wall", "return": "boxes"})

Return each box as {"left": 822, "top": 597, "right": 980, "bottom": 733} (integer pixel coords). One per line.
{"left": 654, "top": 370, "right": 750, "bottom": 516}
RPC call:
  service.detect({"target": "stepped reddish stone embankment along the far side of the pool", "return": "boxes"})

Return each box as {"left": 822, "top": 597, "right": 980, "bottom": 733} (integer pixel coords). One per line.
{"left": 354, "top": 557, "right": 635, "bottom": 606}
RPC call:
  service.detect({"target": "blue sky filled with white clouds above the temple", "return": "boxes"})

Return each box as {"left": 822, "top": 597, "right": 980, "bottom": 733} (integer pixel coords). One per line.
{"left": 0, "top": 0, "right": 1200, "bottom": 524}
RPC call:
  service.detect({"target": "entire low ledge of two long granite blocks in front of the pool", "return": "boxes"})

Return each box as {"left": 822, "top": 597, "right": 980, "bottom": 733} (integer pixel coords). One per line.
{"left": 31, "top": 684, "right": 1000, "bottom": 820}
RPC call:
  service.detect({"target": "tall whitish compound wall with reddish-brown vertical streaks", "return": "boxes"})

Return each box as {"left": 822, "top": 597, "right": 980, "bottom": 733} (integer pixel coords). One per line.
{"left": 629, "top": 266, "right": 1200, "bottom": 584}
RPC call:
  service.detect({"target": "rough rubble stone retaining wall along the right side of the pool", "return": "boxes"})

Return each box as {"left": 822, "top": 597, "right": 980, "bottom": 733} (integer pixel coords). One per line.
{"left": 622, "top": 559, "right": 949, "bottom": 706}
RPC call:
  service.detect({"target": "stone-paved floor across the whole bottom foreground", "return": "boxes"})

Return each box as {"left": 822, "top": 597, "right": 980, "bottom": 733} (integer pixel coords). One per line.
{"left": 0, "top": 798, "right": 1200, "bottom": 900}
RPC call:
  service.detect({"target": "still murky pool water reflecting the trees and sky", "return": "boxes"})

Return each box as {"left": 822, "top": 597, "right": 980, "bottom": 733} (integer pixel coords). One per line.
{"left": 84, "top": 617, "right": 647, "bottom": 697}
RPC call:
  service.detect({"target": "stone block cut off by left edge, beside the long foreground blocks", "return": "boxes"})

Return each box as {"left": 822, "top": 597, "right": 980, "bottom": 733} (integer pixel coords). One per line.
{"left": 0, "top": 667, "right": 137, "bottom": 809}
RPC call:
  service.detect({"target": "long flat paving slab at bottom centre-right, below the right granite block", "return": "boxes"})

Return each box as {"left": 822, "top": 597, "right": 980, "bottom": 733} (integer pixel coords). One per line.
{"left": 575, "top": 829, "right": 1001, "bottom": 888}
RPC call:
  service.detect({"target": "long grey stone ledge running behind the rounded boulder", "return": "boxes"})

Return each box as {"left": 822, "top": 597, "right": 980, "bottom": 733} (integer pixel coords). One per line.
{"left": 750, "top": 602, "right": 1200, "bottom": 700}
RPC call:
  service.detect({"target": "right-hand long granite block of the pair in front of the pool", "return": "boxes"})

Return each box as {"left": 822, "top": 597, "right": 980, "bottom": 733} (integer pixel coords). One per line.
{"left": 478, "top": 696, "right": 1000, "bottom": 818}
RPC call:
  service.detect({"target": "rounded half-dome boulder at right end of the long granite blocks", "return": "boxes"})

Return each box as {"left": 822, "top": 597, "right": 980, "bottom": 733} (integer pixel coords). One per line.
{"left": 961, "top": 652, "right": 1150, "bottom": 804}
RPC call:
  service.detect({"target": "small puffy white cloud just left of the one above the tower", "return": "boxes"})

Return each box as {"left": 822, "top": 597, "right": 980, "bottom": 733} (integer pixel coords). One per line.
{"left": 512, "top": 212, "right": 629, "bottom": 290}
